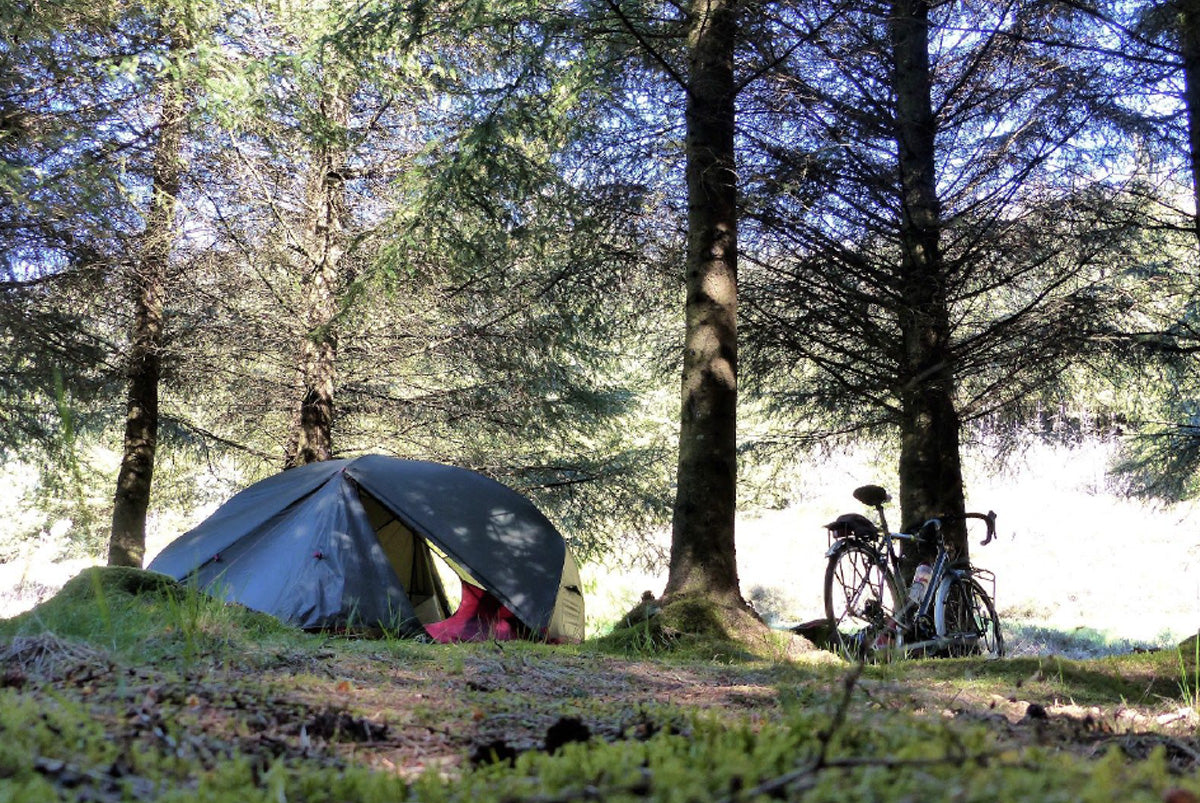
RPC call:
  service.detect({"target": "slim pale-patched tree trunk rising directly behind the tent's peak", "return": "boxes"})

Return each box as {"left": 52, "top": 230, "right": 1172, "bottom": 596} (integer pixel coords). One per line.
{"left": 284, "top": 89, "right": 349, "bottom": 468}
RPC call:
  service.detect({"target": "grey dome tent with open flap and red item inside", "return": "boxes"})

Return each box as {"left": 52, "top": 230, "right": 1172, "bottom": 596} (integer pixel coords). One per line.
{"left": 148, "top": 455, "right": 583, "bottom": 641}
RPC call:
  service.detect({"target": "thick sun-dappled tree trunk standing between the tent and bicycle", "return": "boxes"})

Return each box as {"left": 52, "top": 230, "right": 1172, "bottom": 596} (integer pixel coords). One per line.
{"left": 666, "top": 0, "right": 740, "bottom": 600}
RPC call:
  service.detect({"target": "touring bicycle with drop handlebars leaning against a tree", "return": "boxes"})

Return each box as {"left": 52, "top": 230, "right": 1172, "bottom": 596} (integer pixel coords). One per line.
{"left": 824, "top": 485, "right": 1004, "bottom": 660}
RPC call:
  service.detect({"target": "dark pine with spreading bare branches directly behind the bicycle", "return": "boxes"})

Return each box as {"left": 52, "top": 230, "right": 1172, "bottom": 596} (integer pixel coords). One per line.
{"left": 744, "top": 2, "right": 1130, "bottom": 555}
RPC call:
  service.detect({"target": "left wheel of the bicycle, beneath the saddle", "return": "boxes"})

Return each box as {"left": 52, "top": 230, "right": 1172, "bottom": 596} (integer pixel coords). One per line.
{"left": 824, "top": 543, "right": 902, "bottom": 660}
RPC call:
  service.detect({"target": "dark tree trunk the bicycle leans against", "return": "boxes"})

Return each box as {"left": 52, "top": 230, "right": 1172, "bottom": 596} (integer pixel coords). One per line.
{"left": 890, "top": 0, "right": 967, "bottom": 558}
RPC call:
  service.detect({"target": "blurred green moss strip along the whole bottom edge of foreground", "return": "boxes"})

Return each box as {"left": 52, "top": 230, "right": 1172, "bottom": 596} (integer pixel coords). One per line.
{"left": 0, "top": 672, "right": 1200, "bottom": 803}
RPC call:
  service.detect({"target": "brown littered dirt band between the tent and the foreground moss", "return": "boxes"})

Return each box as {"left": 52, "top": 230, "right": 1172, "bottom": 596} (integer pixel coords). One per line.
{"left": 9, "top": 636, "right": 1200, "bottom": 798}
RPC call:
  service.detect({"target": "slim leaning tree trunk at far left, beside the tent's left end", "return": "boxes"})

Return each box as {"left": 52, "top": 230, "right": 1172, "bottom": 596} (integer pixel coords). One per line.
{"left": 108, "top": 70, "right": 186, "bottom": 568}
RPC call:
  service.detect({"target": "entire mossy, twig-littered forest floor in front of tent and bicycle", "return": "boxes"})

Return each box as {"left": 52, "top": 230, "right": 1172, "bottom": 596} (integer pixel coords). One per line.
{"left": 0, "top": 570, "right": 1200, "bottom": 803}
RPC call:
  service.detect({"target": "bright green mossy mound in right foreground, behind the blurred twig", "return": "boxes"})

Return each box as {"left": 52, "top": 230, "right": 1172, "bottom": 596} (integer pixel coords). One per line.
{"left": 448, "top": 712, "right": 1200, "bottom": 802}
